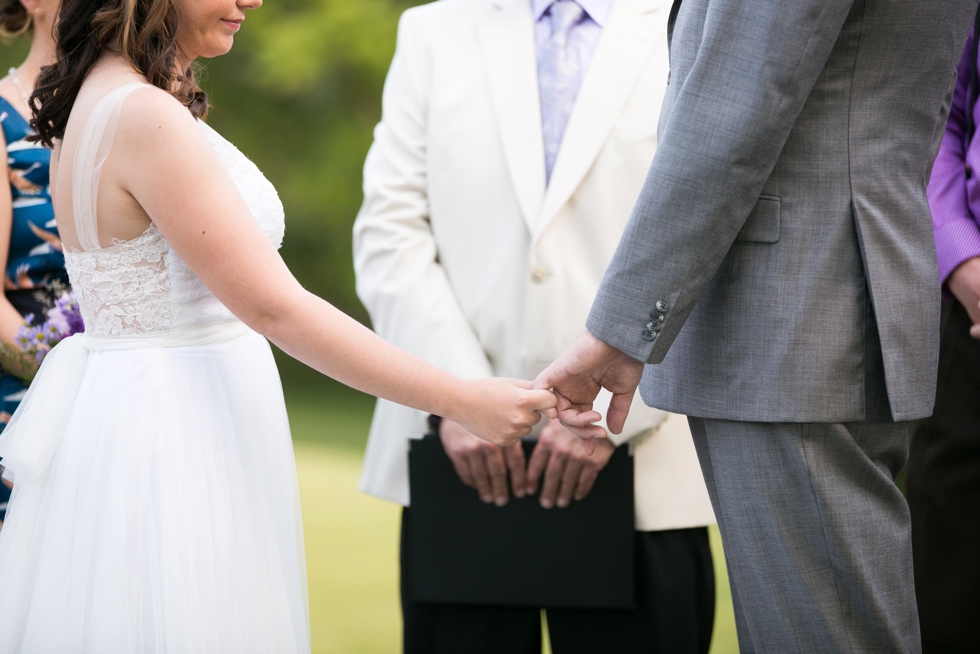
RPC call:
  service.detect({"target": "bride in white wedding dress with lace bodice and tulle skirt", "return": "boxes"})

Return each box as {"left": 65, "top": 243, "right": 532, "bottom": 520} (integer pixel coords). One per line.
{"left": 0, "top": 0, "right": 555, "bottom": 654}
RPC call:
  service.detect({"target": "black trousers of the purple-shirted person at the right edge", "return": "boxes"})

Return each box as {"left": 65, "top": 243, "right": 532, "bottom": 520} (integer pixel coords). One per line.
{"left": 907, "top": 302, "right": 980, "bottom": 654}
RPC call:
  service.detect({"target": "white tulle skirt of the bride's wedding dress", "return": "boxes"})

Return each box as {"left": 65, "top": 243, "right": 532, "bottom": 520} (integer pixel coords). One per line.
{"left": 0, "top": 331, "right": 310, "bottom": 654}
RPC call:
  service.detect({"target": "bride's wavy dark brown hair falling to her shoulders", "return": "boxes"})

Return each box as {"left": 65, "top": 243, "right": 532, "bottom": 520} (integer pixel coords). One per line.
{"left": 30, "top": 0, "right": 208, "bottom": 148}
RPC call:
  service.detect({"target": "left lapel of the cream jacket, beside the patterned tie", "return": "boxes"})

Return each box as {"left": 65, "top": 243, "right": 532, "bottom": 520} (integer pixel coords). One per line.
{"left": 477, "top": 0, "right": 545, "bottom": 231}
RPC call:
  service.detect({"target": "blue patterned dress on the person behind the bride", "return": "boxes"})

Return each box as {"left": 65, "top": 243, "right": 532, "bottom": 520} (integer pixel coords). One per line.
{"left": 0, "top": 98, "right": 68, "bottom": 520}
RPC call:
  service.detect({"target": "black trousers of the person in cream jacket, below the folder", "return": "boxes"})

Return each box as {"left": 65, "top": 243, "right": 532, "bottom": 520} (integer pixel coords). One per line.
{"left": 401, "top": 509, "right": 715, "bottom": 654}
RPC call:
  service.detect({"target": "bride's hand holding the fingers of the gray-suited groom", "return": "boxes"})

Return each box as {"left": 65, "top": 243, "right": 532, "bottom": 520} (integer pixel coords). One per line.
{"left": 445, "top": 378, "right": 558, "bottom": 445}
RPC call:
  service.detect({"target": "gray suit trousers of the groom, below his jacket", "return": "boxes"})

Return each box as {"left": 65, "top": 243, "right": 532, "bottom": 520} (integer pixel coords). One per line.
{"left": 690, "top": 418, "right": 921, "bottom": 654}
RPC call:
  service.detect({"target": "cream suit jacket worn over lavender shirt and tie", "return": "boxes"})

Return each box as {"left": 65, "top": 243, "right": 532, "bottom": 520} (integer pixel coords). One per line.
{"left": 354, "top": 0, "right": 714, "bottom": 530}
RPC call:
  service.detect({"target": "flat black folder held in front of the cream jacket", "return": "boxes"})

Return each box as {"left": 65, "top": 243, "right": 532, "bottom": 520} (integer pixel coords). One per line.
{"left": 407, "top": 436, "right": 634, "bottom": 609}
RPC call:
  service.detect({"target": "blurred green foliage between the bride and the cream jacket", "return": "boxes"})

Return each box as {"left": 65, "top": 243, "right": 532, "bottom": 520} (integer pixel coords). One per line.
{"left": 202, "top": 0, "right": 419, "bottom": 322}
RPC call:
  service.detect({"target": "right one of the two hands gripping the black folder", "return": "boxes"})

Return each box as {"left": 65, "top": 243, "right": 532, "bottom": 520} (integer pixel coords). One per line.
{"left": 527, "top": 420, "right": 616, "bottom": 509}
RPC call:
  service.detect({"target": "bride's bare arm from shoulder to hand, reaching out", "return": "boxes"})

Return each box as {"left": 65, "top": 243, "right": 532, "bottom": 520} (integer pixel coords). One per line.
{"left": 106, "top": 90, "right": 555, "bottom": 444}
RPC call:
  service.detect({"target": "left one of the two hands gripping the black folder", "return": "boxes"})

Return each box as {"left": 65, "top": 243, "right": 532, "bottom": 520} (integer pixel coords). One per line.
{"left": 439, "top": 419, "right": 527, "bottom": 506}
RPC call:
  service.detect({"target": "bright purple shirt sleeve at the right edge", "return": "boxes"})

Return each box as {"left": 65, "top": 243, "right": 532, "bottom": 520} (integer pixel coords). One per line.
{"left": 928, "top": 32, "right": 980, "bottom": 285}
